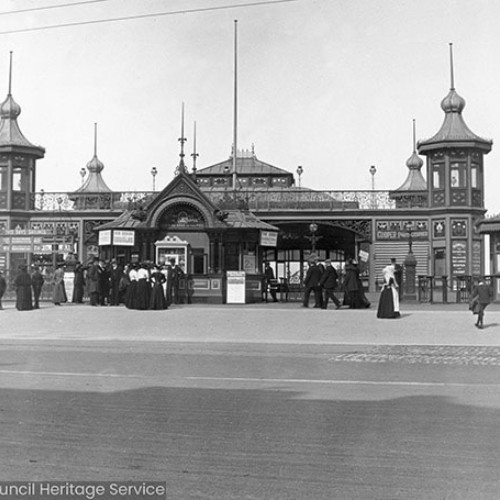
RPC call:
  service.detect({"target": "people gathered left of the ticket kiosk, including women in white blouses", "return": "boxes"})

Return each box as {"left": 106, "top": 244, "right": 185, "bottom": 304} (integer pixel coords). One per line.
{"left": 0, "top": 257, "right": 185, "bottom": 311}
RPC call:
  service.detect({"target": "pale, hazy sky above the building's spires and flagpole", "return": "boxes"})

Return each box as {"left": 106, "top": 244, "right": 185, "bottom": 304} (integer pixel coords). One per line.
{"left": 0, "top": 0, "right": 500, "bottom": 214}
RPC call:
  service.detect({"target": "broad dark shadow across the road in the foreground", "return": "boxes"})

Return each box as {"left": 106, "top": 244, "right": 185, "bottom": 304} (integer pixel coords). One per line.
{"left": 0, "top": 387, "right": 500, "bottom": 500}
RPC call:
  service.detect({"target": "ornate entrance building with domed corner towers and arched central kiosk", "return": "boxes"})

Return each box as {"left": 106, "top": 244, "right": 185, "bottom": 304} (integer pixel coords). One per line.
{"left": 0, "top": 56, "right": 492, "bottom": 302}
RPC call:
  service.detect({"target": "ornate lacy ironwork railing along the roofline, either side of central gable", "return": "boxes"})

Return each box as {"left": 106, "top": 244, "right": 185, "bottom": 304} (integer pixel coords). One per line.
{"left": 32, "top": 189, "right": 396, "bottom": 212}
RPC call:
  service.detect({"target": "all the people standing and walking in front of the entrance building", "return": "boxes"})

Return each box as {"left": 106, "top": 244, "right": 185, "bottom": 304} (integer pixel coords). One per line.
{"left": 0, "top": 254, "right": 493, "bottom": 328}
